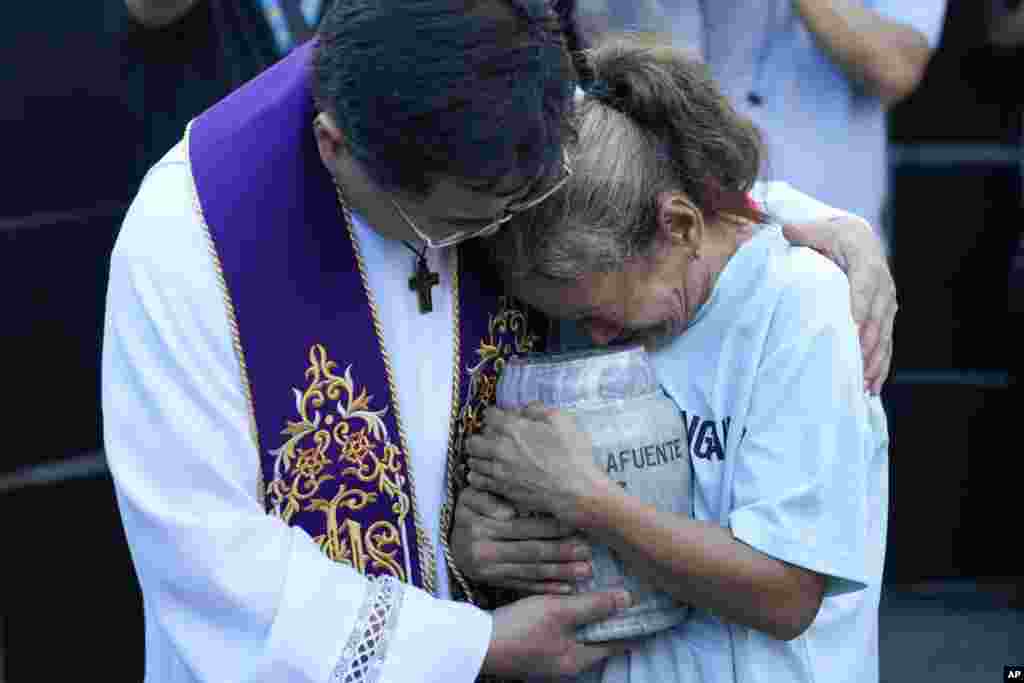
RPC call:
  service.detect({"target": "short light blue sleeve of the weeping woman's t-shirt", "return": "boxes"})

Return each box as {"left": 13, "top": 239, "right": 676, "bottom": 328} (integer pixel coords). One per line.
{"left": 729, "top": 248, "right": 878, "bottom": 595}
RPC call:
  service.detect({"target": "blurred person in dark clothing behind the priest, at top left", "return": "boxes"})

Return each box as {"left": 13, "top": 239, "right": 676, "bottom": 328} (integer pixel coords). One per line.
{"left": 124, "top": 0, "right": 331, "bottom": 178}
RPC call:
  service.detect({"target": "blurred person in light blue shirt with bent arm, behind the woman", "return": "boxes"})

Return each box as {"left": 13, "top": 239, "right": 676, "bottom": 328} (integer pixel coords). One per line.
{"left": 580, "top": 0, "right": 946, "bottom": 250}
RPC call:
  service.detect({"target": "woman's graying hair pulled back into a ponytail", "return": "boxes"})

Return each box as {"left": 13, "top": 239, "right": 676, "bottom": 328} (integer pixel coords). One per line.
{"left": 492, "top": 37, "right": 764, "bottom": 280}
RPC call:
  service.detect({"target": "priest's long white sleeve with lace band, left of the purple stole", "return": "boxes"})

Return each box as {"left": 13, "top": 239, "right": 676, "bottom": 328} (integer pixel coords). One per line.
{"left": 102, "top": 148, "right": 492, "bottom": 683}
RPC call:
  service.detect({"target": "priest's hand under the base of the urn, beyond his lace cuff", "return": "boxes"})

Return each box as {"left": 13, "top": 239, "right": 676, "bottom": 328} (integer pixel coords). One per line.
{"left": 481, "top": 591, "right": 632, "bottom": 678}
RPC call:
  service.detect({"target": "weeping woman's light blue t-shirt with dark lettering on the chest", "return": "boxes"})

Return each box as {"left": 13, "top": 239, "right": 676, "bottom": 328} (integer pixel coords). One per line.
{"left": 583, "top": 225, "right": 889, "bottom": 683}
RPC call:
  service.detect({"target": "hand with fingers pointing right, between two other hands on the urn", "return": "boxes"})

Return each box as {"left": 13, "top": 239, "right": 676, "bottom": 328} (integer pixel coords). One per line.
{"left": 452, "top": 486, "right": 592, "bottom": 594}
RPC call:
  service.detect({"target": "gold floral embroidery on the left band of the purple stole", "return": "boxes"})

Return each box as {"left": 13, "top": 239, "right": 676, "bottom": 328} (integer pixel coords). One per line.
{"left": 266, "top": 344, "right": 411, "bottom": 581}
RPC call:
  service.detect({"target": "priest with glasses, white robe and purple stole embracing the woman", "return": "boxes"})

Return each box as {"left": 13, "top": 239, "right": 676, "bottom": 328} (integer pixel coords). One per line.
{"left": 103, "top": 0, "right": 892, "bottom": 683}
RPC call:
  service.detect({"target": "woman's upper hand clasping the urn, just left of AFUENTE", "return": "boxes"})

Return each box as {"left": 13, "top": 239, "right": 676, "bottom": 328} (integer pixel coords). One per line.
{"left": 466, "top": 403, "right": 614, "bottom": 527}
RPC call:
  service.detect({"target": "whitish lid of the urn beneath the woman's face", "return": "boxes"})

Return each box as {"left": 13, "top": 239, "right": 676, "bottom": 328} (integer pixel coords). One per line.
{"left": 498, "top": 345, "right": 659, "bottom": 410}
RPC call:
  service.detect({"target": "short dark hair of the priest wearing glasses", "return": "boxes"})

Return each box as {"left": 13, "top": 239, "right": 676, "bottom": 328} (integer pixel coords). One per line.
{"left": 313, "top": 0, "right": 575, "bottom": 196}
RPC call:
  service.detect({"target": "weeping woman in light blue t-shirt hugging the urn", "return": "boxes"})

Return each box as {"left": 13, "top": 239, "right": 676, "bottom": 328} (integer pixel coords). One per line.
{"left": 468, "top": 41, "right": 888, "bottom": 683}
